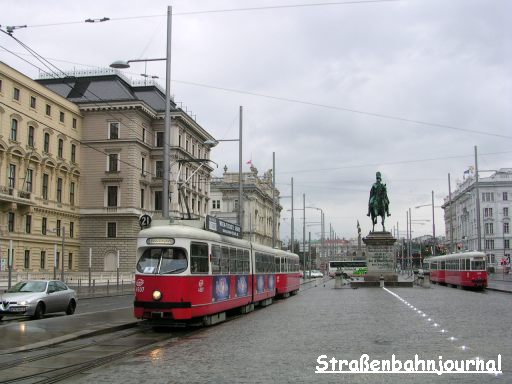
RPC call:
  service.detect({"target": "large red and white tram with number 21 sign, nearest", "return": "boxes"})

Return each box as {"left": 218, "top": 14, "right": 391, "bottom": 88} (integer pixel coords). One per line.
{"left": 134, "top": 220, "right": 300, "bottom": 325}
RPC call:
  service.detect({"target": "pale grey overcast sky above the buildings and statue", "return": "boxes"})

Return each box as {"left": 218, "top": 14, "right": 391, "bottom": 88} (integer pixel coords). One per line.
{"left": 0, "top": 0, "right": 512, "bottom": 241}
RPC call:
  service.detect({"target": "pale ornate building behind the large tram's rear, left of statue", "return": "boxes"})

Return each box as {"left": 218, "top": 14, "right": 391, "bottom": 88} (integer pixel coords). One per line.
{"left": 210, "top": 166, "right": 282, "bottom": 248}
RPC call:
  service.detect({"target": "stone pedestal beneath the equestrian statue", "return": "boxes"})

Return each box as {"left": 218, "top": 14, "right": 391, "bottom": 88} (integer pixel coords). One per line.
{"left": 363, "top": 232, "right": 398, "bottom": 282}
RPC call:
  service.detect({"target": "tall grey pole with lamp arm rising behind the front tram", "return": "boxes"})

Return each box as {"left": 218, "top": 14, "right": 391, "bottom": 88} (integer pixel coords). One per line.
{"left": 110, "top": 6, "right": 172, "bottom": 219}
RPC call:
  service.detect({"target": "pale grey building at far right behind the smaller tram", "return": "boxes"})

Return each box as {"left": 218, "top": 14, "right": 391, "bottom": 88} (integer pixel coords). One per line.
{"left": 443, "top": 168, "right": 512, "bottom": 267}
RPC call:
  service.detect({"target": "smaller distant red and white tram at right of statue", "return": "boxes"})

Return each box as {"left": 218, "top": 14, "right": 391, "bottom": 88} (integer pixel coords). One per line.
{"left": 423, "top": 251, "right": 487, "bottom": 289}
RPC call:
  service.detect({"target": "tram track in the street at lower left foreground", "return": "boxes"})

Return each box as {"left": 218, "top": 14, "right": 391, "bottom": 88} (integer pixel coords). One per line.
{"left": 0, "top": 325, "right": 201, "bottom": 384}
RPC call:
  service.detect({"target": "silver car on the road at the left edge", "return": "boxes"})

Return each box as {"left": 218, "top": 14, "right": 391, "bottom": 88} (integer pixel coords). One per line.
{"left": 0, "top": 280, "right": 77, "bottom": 320}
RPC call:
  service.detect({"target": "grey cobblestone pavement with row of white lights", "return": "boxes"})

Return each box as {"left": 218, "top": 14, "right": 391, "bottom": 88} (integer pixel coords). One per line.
{"left": 66, "top": 281, "right": 512, "bottom": 384}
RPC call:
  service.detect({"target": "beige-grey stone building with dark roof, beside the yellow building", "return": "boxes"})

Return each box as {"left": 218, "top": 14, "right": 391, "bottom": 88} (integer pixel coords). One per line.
{"left": 37, "top": 70, "right": 213, "bottom": 271}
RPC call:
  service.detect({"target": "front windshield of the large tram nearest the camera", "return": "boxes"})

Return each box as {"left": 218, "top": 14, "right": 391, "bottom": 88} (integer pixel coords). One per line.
{"left": 137, "top": 248, "right": 188, "bottom": 275}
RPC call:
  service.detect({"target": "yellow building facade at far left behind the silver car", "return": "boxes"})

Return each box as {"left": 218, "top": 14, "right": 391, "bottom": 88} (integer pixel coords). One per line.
{"left": 0, "top": 62, "right": 82, "bottom": 272}
